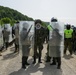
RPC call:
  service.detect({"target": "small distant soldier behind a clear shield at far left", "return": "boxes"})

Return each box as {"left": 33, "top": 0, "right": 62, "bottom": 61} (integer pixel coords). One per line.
{"left": 2, "top": 25, "right": 10, "bottom": 50}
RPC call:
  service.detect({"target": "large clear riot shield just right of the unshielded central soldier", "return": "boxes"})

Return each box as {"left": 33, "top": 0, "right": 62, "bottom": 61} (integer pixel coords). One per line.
{"left": 49, "top": 22, "right": 64, "bottom": 57}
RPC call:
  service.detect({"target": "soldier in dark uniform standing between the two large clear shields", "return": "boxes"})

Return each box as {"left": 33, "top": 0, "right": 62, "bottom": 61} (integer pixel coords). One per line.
{"left": 33, "top": 20, "right": 44, "bottom": 64}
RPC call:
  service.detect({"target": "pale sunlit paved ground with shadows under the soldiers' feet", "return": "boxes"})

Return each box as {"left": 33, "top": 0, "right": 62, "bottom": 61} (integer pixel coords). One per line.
{"left": 0, "top": 45, "right": 76, "bottom": 75}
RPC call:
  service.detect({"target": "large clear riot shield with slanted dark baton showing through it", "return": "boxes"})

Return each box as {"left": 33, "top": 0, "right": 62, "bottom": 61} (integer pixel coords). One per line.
{"left": 19, "top": 21, "right": 34, "bottom": 56}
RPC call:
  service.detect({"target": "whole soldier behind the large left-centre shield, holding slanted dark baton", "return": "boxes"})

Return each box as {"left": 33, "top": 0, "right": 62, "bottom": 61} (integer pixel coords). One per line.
{"left": 20, "top": 22, "right": 32, "bottom": 69}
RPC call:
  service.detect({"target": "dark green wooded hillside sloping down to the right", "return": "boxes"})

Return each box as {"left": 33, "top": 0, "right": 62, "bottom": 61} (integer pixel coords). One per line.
{"left": 0, "top": 6, "right": 33, "bottom": 21}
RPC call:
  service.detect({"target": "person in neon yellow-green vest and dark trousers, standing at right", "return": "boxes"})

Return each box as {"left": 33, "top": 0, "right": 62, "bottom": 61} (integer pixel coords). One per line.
{"left": 64, "top": 24, "right": 73, "bottom": 55}
